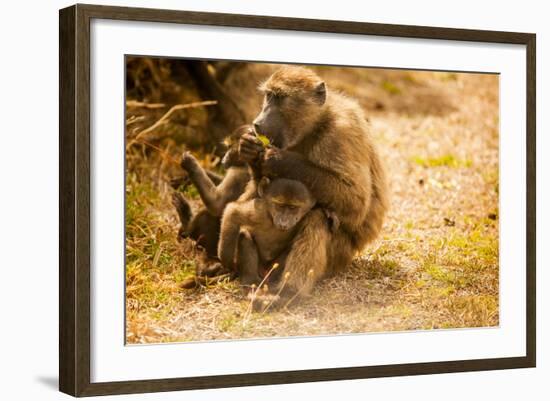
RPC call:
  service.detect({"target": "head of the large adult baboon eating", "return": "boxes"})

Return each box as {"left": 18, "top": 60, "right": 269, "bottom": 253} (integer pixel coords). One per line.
{"left": 253, "top": 68, "right": 326, "bottom": 148}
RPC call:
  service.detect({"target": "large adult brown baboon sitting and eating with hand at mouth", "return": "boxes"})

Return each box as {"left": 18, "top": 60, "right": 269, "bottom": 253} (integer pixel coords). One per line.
{"left": 239, "top": 67, "right": 388, "bottom": 300}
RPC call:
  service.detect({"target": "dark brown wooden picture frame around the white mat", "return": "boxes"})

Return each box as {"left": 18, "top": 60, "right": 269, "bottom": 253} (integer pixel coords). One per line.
{"left": 59, "top": 4, "right": 536, "bottom": 396}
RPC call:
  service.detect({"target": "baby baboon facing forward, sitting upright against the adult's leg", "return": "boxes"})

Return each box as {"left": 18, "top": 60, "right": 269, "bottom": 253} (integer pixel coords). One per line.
{"left": 218, "top": 178, "right": 315, "bottom": 285}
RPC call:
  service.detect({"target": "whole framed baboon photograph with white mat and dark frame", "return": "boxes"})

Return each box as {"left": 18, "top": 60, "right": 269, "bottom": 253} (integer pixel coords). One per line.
{"left": 59, "top": 5, "right": 536, "bottom": 396}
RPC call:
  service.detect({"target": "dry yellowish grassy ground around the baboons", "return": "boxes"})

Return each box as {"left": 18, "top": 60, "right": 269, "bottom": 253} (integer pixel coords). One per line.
{"left": 126, "top": 64, "right": 499, "bottom": 343}
